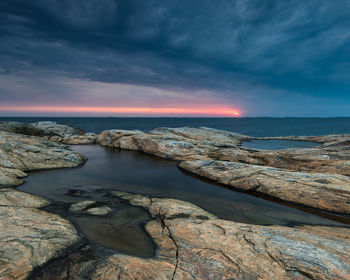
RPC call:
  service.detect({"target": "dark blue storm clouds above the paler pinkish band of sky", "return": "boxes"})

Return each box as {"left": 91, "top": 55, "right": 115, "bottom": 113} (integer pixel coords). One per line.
{"left": 0, "top": 0, "right": 350, "bottom": 115}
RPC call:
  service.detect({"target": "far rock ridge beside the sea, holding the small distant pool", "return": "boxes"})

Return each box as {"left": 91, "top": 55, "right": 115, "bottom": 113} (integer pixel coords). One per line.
{"left": 97, "top": 127, "right": 350, "bottom": 175}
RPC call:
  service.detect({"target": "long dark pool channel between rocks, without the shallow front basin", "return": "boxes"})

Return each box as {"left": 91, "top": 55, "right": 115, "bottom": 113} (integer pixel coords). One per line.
{"left": 20, "top": 145, "right": 348, "bottom": 225}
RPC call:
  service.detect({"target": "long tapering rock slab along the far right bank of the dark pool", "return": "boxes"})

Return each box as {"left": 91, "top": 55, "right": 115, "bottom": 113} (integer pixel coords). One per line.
{"left": 179, "top": 160, "right": 350, "bottom": 214}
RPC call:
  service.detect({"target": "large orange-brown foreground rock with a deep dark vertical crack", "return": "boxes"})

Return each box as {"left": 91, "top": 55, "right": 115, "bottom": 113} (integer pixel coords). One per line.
{"left": 42, "top": 192, "right": 350, "bottom": 280}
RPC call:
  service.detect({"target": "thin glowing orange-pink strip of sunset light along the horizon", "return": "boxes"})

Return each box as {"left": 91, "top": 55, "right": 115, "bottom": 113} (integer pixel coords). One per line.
{"left": 0, "top": 106, "right": 241, "bottom": 117}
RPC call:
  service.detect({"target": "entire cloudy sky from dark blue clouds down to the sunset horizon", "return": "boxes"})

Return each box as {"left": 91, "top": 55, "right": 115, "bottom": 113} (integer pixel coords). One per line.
{"left": 0, "top": 0, "right": 350, "bottom": 117}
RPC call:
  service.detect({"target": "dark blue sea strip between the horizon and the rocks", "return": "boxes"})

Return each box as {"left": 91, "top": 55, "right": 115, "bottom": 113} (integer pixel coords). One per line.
{"left": 0, "top": 117, "right": 350, "bottom": 137}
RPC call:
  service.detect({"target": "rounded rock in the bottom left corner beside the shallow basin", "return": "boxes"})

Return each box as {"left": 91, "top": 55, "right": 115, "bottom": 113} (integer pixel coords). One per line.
{"left": 0, "top": 189, "right": 79, "bottom": 280}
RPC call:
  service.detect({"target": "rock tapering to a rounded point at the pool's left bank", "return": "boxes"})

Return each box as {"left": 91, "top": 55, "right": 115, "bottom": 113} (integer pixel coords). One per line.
{"left": 0, "top": 131, "right": 86, "bottom": 186}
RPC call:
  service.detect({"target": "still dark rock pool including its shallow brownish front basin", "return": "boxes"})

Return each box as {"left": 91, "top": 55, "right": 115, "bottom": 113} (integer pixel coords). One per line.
{"left": 19, "top": 145, "right": 350, "bottom": 256}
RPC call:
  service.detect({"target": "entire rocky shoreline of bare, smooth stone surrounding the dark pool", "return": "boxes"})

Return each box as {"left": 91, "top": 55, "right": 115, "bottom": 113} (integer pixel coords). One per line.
{"left": 0, "top": 122, "right": 350, "bottom": 279}
